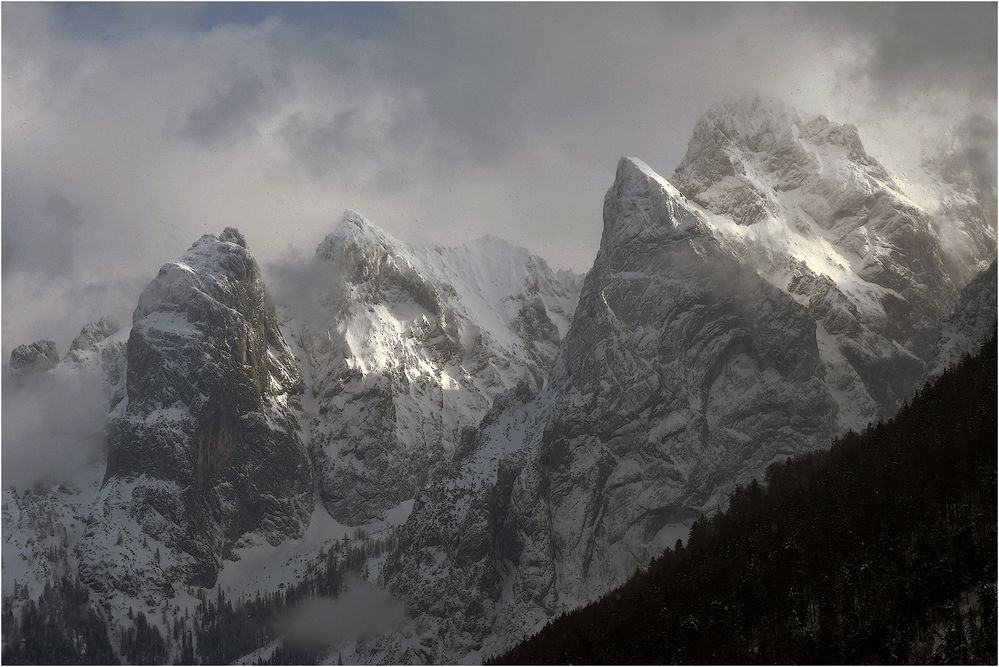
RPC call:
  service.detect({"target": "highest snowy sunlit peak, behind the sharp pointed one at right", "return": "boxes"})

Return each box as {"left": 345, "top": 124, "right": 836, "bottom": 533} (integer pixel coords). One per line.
{"left": 671, "top": 95, "right": 995, "bottom": 428}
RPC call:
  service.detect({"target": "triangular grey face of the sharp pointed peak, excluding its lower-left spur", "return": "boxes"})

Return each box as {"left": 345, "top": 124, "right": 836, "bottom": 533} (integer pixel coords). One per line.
{"left": 520, "top": 158, "right": 834, "bottom": 588}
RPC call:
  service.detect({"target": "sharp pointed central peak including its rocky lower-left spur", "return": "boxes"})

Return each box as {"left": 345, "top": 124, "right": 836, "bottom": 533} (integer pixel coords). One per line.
{"left": 378, "top": 159, "right": 835, "bottom": 661}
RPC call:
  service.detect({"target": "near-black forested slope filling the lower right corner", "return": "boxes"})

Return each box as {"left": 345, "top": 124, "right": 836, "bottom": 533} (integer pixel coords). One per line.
{"left": 495, "top": 334, "right": 996, "bottom": 664}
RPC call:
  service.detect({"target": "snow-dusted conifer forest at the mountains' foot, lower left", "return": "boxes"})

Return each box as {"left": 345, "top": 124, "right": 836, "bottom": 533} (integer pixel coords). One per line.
{"left": 0, "top": 529, "right": 396, "bottom": 665}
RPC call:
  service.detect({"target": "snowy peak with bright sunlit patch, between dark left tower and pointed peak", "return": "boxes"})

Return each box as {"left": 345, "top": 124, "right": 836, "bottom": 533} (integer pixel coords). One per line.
{"left": 286, "top": 211, "right": 579, "bottom": 525}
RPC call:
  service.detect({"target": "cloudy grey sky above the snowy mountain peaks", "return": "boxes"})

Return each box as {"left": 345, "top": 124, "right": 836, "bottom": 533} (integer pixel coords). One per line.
{"left": 2, "top": 3, "right": 996, "bottom": 357}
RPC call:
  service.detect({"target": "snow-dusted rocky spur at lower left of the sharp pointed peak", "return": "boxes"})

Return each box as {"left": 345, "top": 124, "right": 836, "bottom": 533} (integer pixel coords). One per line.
{"left": 360, "top": 384, "right": 545, "bottom": 664}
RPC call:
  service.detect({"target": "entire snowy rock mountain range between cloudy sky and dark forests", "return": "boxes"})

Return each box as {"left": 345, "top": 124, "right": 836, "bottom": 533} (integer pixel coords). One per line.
{"left": 4, "top": 92, "right": 995, "bottom": 662}
